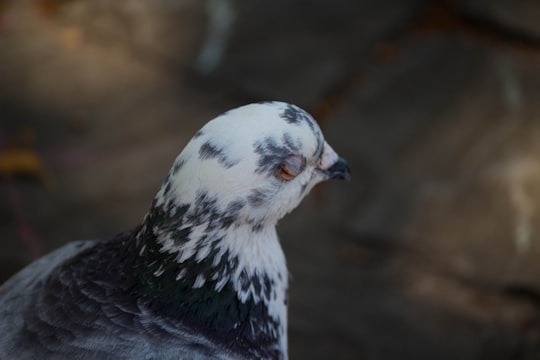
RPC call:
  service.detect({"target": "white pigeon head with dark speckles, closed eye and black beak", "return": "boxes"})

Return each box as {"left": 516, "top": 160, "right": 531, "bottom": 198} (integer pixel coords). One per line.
{"left": 156, "top": 102, "right": 349, "bottom": 230}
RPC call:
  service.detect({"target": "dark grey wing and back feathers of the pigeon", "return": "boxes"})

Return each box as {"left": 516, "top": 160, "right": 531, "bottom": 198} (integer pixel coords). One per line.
{"left": 0, "top": 235, "right": 242, "bottom": 360}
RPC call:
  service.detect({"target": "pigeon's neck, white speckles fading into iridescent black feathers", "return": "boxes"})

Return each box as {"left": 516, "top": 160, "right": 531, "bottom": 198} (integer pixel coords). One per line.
{"left": 131, "top": 198, "right": 287, "bottom": 358}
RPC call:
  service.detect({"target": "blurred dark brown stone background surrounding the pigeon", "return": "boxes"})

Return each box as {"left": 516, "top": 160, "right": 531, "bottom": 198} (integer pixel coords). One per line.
{"left": 0, "top": 0, "right": 540, "bottom": 360}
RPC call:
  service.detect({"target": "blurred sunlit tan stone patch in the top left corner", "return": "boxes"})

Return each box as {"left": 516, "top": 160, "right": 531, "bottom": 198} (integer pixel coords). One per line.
{"left": 0, "top": 0, "right": 206, "bottom": 111}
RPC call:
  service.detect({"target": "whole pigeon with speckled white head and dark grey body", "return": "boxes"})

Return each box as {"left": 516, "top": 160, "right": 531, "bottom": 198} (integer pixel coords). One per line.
{"left": 0, "top": 101, "right": 350, "bottom": 360}
